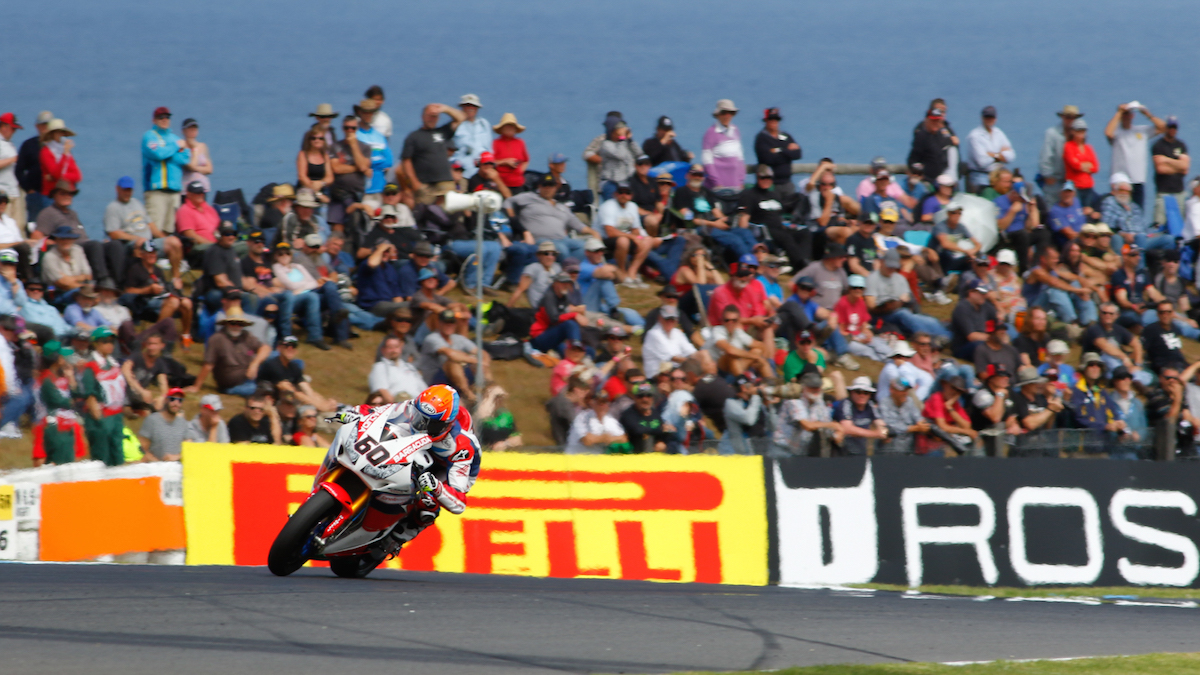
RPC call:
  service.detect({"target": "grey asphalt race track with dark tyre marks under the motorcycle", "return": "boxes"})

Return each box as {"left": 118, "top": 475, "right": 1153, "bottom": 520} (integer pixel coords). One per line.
{"left": 0, "top": 565, "right": 1200, "bottom": 675}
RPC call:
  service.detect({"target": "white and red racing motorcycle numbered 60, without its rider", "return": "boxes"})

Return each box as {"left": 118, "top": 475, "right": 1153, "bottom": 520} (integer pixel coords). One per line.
{"left": 266, "top": 407, "right": 433, "bottom": 578}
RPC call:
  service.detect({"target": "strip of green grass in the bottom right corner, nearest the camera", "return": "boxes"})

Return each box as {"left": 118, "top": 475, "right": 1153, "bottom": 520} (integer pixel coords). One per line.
{"left": 679, "top": 653, "right": 1200, "bottom": 675}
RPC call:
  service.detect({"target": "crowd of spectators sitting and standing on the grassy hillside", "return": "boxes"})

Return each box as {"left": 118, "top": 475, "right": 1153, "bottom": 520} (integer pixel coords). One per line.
{"left": 0, "top": 86, "right": 1200, "bottom": 465}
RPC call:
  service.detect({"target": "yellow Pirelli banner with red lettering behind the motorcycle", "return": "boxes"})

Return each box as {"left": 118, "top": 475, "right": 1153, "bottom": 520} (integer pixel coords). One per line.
{"left": 182, "top": 443, "right": 768, "bottom": 585}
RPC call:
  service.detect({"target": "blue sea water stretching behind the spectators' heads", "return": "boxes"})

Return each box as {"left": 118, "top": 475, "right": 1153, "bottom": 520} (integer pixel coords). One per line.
{"left": 0, "top": 0, "right": 1200, "bottom": 235}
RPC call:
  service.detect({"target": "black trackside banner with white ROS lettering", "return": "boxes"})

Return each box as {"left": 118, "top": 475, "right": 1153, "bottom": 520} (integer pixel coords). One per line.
{"left": 766, "top": 456, "right": 1200, "bottom": 586}
